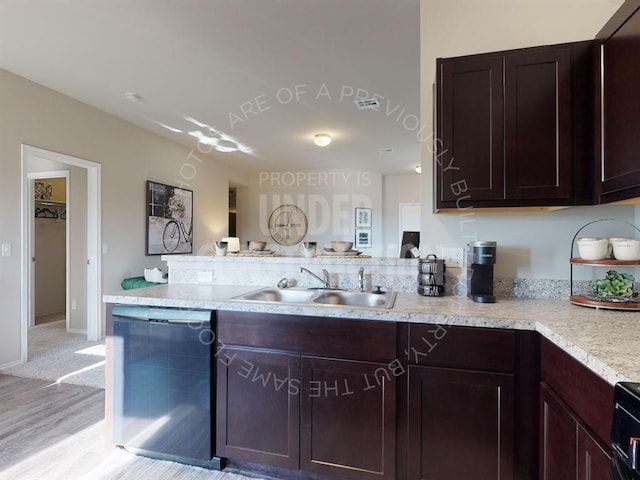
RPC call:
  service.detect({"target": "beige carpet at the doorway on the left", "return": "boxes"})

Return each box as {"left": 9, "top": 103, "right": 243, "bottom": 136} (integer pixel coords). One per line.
{"left": 0, "top": 321, "right": 104, "bottom": 388}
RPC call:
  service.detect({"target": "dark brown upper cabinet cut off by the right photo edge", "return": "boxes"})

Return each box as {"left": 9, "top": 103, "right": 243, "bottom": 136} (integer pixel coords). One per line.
{"left": 595, "top": 0, "right": 640, "bottom": 203}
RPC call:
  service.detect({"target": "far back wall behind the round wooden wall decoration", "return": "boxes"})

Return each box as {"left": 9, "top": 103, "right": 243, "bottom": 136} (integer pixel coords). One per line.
{"left": 237, "top": 170, "right": 384, "bottom": 256}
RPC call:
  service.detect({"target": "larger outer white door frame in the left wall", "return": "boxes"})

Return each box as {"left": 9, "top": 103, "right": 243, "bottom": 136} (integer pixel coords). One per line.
{"left": 20, "top": 144, "right": 103, "bottom": 362}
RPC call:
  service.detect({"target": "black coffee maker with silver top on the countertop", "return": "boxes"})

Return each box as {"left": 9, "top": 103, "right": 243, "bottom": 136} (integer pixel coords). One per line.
{"left": 467, "top": 242, "right": 496, "bottom": 303}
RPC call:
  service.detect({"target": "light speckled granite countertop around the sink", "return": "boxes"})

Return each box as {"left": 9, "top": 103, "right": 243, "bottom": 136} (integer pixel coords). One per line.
{"left": 103, "top": 284, "right": 640, "bottom": 385}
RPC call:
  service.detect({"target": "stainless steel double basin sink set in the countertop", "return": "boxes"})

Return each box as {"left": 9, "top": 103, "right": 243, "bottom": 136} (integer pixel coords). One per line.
{"left": 234, "top": 288, "right": 396, "bottom": 308}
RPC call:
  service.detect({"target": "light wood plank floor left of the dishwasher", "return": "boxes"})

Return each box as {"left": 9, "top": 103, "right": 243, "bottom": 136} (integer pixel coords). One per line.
{"left": 0, "top": 375, "right": 264, "bottom": 480}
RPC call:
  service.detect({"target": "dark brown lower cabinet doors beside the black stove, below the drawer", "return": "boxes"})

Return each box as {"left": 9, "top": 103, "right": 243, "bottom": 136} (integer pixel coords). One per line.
{"left": 540, "top": 383, "right": 611, "bottom": 480}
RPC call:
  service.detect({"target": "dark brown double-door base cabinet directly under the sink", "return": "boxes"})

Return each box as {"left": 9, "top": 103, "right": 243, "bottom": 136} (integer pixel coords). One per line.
{"left": 216, "top": 311, "right": 398, "bottom": 480}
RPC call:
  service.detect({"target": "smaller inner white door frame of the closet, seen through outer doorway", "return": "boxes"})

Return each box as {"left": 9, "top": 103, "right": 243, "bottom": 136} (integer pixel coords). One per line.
{"left": 27, "top": 170, "right": 71, "bottom": 330}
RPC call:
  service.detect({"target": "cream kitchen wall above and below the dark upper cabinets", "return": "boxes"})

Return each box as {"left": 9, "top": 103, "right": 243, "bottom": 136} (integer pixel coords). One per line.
{"left": 420, "top": 0, "right": 635, "bottom": 279}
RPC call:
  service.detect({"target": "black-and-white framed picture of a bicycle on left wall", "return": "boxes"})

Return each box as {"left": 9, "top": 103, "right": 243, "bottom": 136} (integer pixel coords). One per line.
{"left": 147, "top": 180, "right": 193, "bottom": 255}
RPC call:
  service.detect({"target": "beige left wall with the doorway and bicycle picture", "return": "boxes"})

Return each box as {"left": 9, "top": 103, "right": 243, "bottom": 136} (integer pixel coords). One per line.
{"left": 0, "top": 70, "right": 247, "bottom": 366}
